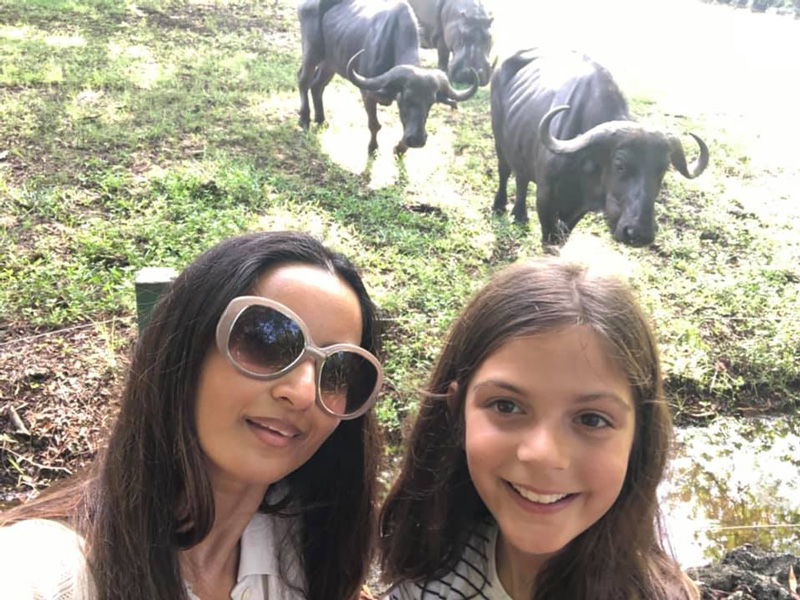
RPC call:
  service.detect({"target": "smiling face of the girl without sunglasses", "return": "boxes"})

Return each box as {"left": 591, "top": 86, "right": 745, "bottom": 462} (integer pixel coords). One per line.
{"left": 464, "top": 326, "right": 635, "bottom": 565}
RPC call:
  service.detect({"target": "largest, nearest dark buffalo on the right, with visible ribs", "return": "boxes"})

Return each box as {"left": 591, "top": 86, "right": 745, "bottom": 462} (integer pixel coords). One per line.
{"left": 491, "top": 49, "right": 708, "bottom": 246}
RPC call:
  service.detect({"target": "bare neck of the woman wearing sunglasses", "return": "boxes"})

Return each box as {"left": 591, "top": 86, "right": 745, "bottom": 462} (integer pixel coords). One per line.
{"left": 179, "top": 482, "right": 266, "bottom": 600}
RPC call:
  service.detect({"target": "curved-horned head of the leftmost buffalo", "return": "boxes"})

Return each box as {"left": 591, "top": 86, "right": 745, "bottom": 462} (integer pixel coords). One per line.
{"left": 347, "top": 50, "right": 478, "bottom": 152}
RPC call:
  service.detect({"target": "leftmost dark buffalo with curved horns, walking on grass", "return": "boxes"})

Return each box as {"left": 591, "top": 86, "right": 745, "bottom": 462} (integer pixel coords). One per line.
{"left": 297, "top": 0, "right": 478, "bottom": 154}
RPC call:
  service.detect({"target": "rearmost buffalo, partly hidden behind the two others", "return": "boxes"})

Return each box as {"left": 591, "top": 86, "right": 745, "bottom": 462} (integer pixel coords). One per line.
{"left": 408, "top": 0, "right": 492, "bottom": 86}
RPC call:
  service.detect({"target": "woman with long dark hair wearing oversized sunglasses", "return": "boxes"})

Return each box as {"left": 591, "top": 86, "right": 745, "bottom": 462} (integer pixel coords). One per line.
{"left": 0, "top": 232, "right": 382, "bottom": 600}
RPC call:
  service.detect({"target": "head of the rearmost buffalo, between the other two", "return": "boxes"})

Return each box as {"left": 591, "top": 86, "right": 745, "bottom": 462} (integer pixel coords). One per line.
{"left": 440, "top": 10, "right": 493, "bottom": 86}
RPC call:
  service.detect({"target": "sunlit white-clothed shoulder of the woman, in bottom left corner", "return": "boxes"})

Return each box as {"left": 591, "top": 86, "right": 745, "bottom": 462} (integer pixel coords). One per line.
{"left": 0, "top": 519, "right": 90, "bottom": 600}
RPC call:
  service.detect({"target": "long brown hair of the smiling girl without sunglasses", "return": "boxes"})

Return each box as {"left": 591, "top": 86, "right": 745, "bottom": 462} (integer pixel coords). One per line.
{"left": 380, "top": 258, "right": 694, "bottom": 600}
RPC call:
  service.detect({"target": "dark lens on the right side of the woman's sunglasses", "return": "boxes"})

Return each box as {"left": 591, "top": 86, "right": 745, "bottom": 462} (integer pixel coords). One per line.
{"left": 319, "top": 351, "right": 378, "bottom": 415}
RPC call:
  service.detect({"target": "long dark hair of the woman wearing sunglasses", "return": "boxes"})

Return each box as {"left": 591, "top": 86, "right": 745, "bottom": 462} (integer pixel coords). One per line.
{"left": 0, "top": 232, "right": 380, "bottom": 600}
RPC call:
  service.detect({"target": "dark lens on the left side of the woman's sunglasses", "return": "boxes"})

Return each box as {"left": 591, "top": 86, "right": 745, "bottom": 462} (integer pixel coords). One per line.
{"left": 233, "top": 305, "right": 305, "bottom": 375}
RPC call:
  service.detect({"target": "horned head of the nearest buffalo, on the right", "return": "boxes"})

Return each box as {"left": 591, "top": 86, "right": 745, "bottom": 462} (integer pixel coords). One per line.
{"left": 539, "top": 106, "right": 708, "bottom": 246}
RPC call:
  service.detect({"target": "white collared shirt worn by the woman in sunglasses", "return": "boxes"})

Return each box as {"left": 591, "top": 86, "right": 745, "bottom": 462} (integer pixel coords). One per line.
{"left": 0, "top": 513, "right": 305, "bottom": 600}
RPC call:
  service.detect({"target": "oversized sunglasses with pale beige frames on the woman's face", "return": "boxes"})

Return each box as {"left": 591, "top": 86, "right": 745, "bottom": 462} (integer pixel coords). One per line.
{"left": 217, "top": 296, "right": 383, "bottom": 419}
